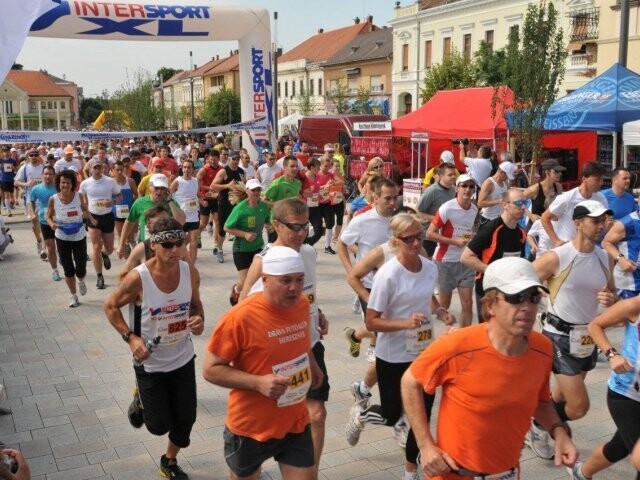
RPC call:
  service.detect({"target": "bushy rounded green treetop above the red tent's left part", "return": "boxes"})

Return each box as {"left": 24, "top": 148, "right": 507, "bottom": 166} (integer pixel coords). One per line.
{"left": 420, "top": 49, "right": 478, "bottom": 103}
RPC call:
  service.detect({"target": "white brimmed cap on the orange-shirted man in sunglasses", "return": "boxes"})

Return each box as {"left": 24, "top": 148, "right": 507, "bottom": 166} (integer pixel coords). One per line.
{"left": 482, "top": 257, "right": 549, "bottom": 295}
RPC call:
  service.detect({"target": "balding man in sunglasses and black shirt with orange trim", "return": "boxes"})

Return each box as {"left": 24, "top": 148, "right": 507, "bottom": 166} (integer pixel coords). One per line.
{"left": 460, "top": 188, "right": 527, "bottom": 323}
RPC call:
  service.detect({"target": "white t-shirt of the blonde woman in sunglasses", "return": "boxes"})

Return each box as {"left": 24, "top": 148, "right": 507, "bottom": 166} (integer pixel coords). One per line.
{"left": 368, "top": 257, "right": 438, "bottom": 363}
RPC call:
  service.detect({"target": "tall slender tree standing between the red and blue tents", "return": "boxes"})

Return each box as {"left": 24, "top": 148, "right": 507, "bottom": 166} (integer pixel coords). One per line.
{"left": 496, "top": 0, "right": 567, "bottom": 161}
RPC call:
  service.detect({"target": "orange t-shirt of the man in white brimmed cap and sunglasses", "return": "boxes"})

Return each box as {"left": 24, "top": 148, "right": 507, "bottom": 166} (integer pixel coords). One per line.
{"left": 410, "top": 323, "right": 553, "bottom": 480}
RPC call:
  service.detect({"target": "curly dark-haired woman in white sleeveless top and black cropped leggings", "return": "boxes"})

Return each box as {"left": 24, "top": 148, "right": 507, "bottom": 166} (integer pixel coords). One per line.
{"left": 47, "top": 170, "right": 91, "bottom": 308}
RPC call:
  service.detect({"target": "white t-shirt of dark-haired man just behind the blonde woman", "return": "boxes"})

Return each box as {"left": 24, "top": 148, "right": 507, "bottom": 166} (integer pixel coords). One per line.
{"left": 340, "top": 207, "right": 391, "bottom": 288}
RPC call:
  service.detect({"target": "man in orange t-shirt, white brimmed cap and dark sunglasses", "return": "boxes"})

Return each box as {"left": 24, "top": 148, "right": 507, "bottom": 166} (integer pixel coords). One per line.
{"left": 402, "top": 258, "right": 578, "bottom": 480}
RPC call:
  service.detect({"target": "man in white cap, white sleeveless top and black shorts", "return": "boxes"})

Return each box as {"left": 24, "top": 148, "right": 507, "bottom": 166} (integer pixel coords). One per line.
{"left": 527, "top": 200, "right": 617, "bottom": 458}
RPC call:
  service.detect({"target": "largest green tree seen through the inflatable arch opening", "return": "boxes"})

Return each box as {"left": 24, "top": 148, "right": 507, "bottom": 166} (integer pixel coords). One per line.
{"left": 106, "top": 69, "right": 162, "bottom": 131}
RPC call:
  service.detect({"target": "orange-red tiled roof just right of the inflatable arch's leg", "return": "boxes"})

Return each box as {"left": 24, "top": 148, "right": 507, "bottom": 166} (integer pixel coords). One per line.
{"left": 278, "top": 22, "right": 377, "bottom": 63}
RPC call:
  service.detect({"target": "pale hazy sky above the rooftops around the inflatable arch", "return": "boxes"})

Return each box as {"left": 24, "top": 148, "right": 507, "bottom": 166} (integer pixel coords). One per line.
{"left": 16, "top": 0, "right": 392, "bottom": 97}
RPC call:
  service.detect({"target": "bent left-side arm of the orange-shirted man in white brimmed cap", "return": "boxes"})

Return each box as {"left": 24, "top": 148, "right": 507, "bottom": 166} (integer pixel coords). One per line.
{"left": 401, "top": 368, "right": 458, "bottom": 477}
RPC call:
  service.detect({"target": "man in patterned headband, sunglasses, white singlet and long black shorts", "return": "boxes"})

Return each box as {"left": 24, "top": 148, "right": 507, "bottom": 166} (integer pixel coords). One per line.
{"left": 104, "top": 218, "right": 204, "bottom": 480}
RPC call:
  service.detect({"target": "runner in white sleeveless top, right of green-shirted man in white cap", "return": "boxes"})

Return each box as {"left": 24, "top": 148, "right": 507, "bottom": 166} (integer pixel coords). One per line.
{"left": 169, "top": 160, "right": 200, "bottom": 264}
